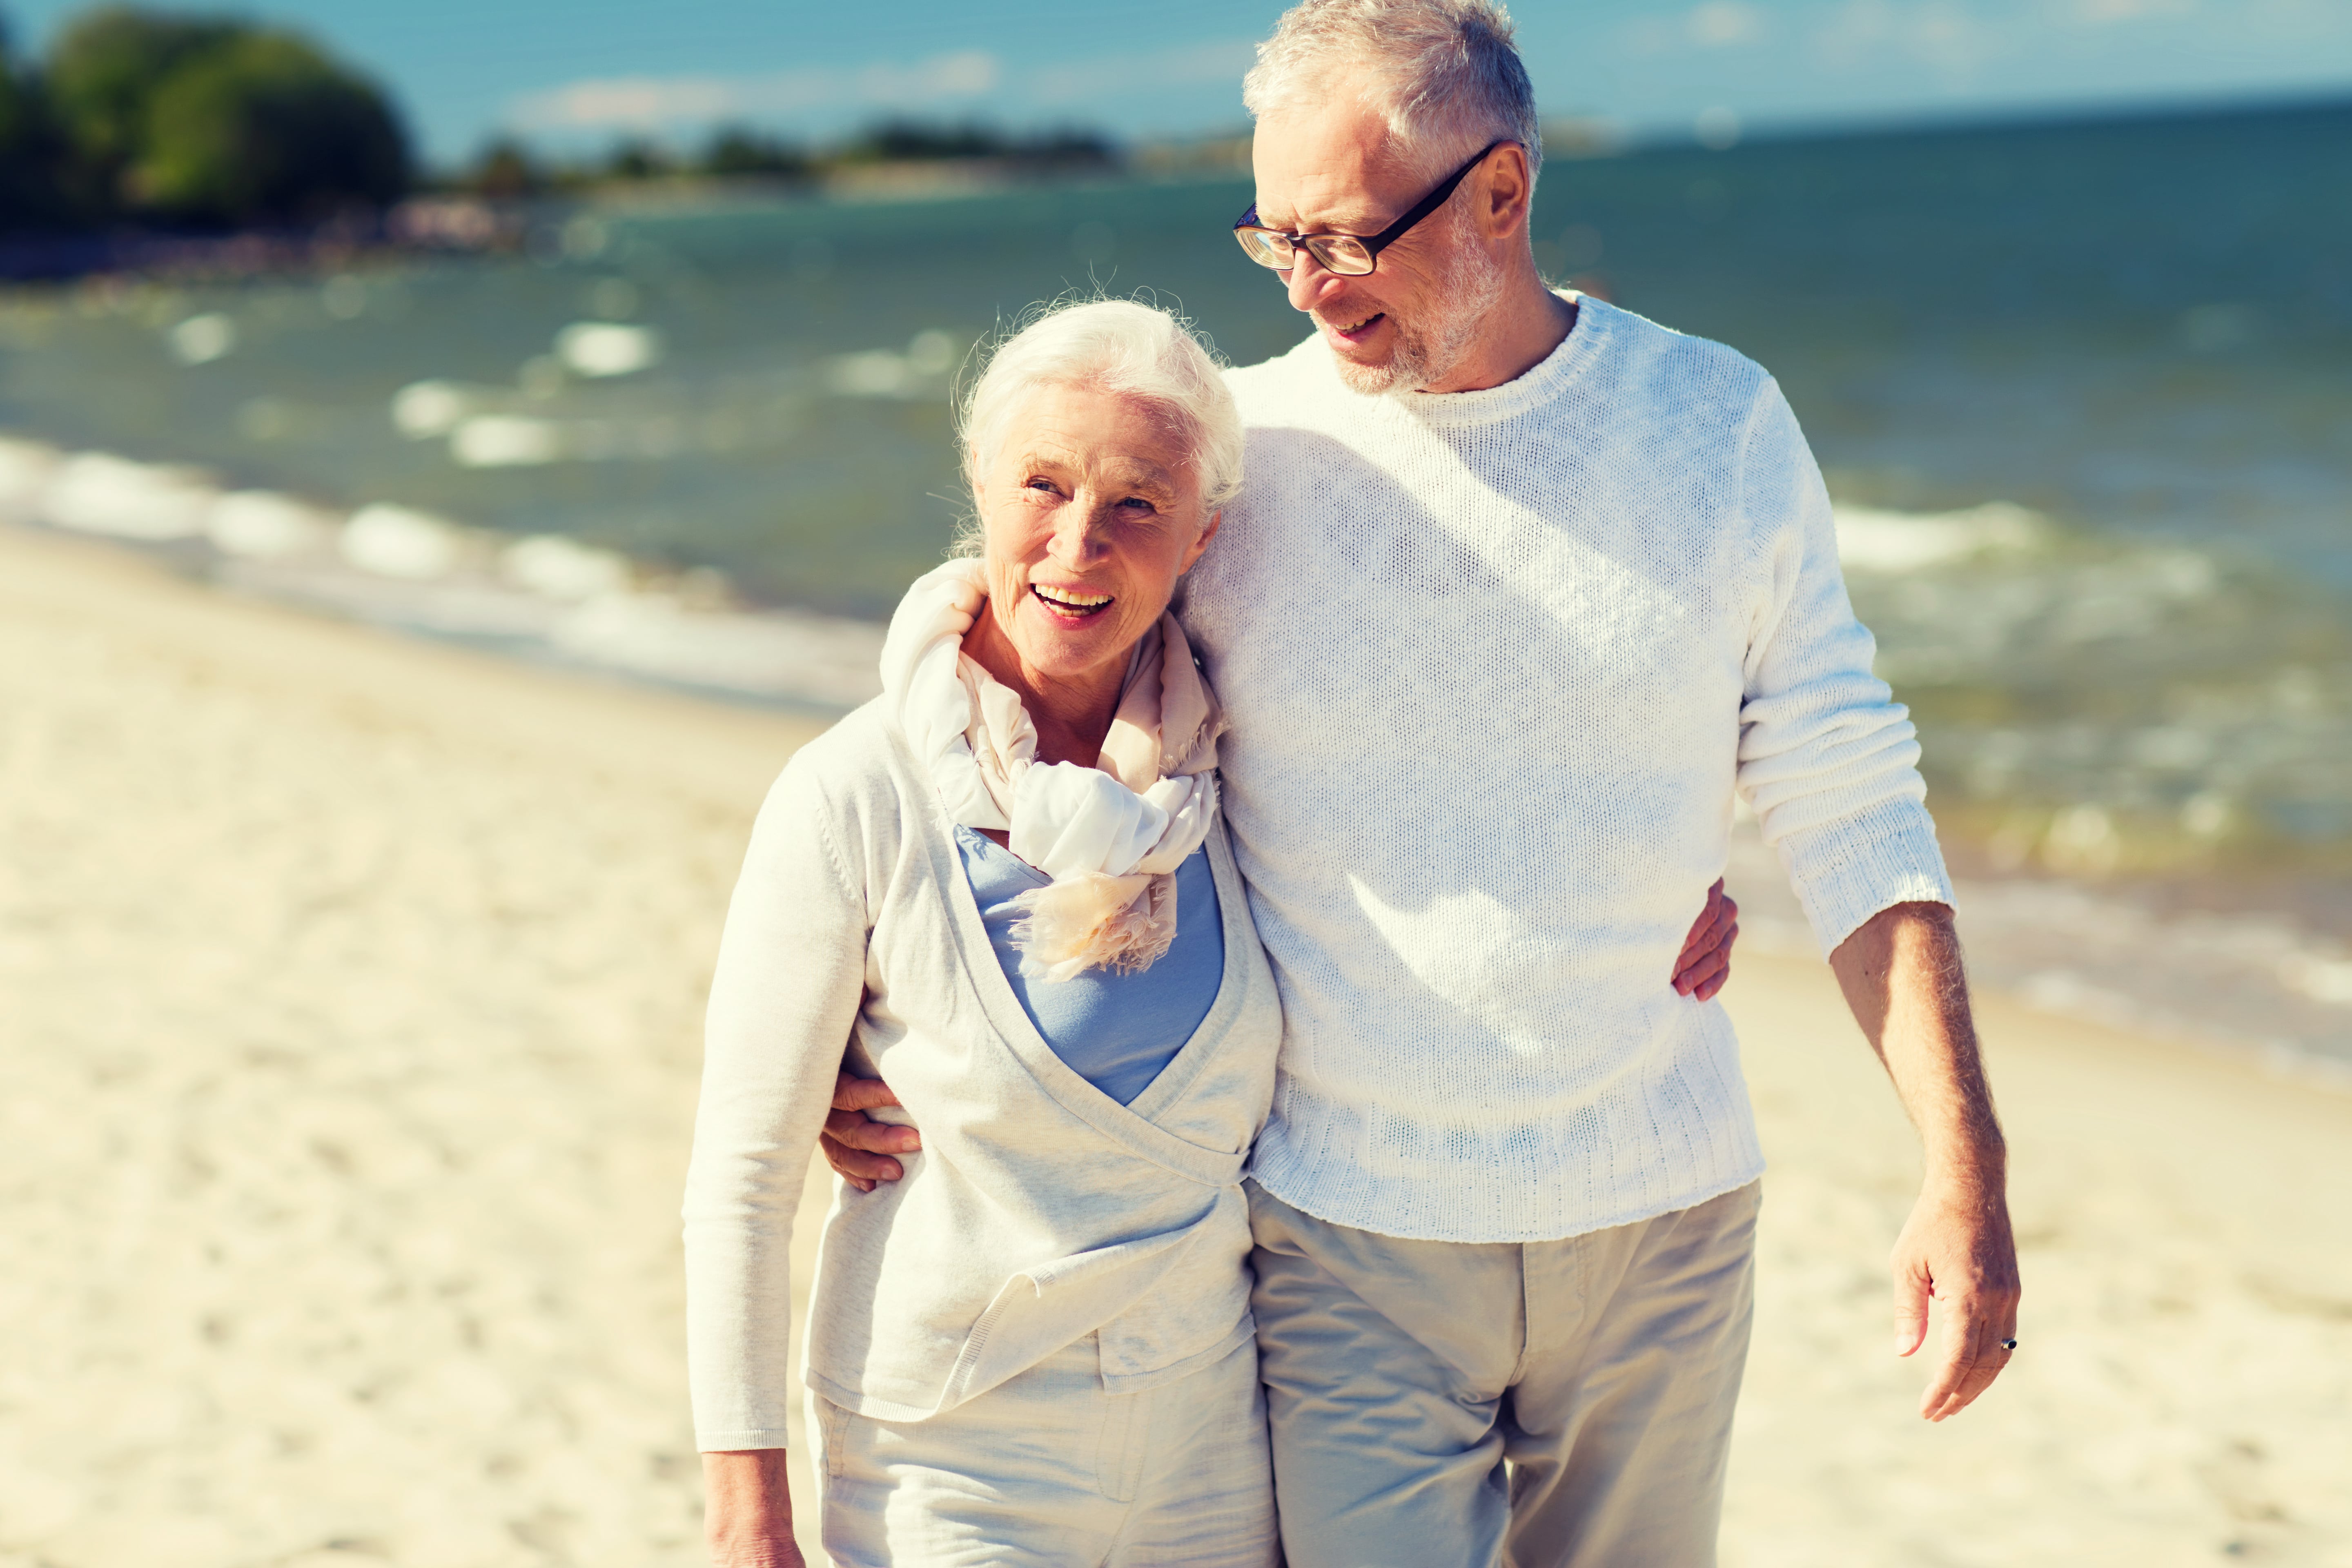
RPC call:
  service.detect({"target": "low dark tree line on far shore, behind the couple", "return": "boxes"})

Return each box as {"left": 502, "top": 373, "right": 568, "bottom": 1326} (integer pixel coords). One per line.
{"left": 454, "top": 120, "right": 1120, "bottom": 198}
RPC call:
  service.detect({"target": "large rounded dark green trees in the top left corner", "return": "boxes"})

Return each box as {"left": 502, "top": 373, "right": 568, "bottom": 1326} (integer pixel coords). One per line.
{"left": 0, "top": 5, "right": 409, "bottom": 233}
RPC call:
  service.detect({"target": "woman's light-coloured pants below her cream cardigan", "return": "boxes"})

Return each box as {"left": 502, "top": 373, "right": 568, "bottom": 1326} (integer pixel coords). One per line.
{"left": 809, "top": 1335, "right": 1277, "bottom": 1568}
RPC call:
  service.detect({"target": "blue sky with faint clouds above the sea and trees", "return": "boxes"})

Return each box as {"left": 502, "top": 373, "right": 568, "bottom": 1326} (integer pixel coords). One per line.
{"left": 0, "top": 0, "right": 2352, "bottom": 160}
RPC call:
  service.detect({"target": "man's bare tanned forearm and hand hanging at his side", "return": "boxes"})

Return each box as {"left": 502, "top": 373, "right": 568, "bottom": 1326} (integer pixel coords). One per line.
{"left": 1830, "top": 903, "right": 2018, "bottom": 1420}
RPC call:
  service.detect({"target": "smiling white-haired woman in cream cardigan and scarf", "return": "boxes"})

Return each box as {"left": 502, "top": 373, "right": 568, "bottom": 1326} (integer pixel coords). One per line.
{"left": 687, "top": 301, "right": 1740, "bottom": 1568}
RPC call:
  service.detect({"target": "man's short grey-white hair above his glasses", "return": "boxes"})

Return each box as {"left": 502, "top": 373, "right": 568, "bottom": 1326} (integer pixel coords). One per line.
{"left": 1242, "top": 0, "right": 1543, "bottom": 179}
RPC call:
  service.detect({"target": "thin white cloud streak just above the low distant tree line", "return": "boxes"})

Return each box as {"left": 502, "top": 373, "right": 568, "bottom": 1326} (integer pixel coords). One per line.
{"left": 506, "top": 49, "right": 1004, "bottom": 131}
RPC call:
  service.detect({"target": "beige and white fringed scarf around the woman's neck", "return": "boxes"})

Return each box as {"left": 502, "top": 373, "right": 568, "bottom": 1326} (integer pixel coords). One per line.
{"left": 882, "top": 559, "right": 1225, "bottom": 980}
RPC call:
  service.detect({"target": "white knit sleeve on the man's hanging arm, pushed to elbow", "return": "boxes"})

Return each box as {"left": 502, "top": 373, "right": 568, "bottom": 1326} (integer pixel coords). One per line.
{"left": 1738, "top": 381, "right": 1952, "bottom": 954}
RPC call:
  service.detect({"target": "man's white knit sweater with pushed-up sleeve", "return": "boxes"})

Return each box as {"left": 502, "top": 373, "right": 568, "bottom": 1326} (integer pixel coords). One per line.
{"left": 1183, "top": 298, "right": 1952, "bottom": 1241}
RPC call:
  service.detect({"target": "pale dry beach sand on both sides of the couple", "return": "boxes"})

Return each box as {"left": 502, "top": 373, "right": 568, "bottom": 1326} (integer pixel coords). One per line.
{"left": 0, "top": 534, "right": 2352, "bottom": 1568}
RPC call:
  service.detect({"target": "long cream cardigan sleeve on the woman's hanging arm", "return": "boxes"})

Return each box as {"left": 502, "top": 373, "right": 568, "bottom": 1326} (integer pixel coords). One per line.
{"left": 684, "top": 760, "right": 868, "bottom": 1453}
